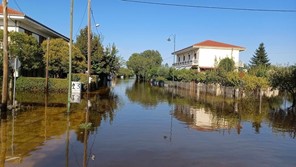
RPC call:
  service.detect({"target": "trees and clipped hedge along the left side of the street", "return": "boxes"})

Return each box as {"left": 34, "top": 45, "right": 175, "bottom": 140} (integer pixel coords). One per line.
{"left": 0, "top": 27, "right": 122, "bottom": 92}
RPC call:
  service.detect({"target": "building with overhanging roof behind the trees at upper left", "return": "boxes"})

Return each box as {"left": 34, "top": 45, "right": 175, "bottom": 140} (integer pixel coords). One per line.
{"left": 0, "top": 5, "right": 69, "bottom": 43}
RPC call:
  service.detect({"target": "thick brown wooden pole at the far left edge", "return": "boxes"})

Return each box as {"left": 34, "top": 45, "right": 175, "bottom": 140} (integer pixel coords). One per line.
{"left": 1, "top": 0, "right": 8, "bottom": 112}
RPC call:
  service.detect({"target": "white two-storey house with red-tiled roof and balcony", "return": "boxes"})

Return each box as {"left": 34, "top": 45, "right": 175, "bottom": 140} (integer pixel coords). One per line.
{"left": 172, "top": 40, "right": 245, "bottom": 71}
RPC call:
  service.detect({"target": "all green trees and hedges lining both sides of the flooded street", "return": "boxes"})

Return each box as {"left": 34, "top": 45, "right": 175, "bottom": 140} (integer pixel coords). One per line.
{"left": 0, "top": 27, "right": 296, "bottom": 106}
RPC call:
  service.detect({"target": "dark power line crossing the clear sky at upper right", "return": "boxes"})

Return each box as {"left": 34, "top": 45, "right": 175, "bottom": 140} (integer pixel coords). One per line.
{"left": 121, "top": 0, "right": 296, "bottom": 13}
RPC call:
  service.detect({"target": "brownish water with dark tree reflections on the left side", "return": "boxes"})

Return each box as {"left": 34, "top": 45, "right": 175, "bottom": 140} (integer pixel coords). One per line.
{"left": 0, "top": 87, "right": 119, "bottom": 166}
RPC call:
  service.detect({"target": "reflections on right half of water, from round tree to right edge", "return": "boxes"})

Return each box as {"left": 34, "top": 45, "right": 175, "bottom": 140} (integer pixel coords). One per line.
{"left": 126, "top": 82, "right": 296, "bottom": 138}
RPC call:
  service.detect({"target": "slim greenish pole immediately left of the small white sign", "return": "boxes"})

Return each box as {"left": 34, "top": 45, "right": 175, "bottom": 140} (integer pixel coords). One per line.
{"left": 67, "top": 0, "right": 74, "bottom": 113}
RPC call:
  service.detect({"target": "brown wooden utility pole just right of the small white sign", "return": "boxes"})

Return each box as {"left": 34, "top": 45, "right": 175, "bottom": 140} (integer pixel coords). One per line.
{"left": 87, "top": 0, "right": 91, "bottom": 93}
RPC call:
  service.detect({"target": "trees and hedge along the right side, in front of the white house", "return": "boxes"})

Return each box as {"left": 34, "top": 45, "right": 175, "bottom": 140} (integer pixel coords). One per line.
{"left": 127, "top": 43, "right": 296, "bottom": 106}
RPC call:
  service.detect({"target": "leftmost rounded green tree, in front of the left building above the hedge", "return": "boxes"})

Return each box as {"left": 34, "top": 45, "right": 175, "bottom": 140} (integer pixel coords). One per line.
{"left": 9, "top": 31, "right": 44, "bottom": 76}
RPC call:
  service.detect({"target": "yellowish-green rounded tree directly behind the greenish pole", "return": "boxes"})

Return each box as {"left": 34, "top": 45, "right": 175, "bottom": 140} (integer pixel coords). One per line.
{"left": 42, "top": 38, "right": 86, "bottom": 78}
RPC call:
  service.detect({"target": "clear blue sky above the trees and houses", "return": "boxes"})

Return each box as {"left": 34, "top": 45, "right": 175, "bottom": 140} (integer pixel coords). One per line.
{"left": 8, "top": 0, "right": 296, "bottom": 66}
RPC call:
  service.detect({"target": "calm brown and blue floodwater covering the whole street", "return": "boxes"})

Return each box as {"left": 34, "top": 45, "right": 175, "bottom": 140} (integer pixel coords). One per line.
{"left": 0, "top": 80, "right": 296, "bottom": 167}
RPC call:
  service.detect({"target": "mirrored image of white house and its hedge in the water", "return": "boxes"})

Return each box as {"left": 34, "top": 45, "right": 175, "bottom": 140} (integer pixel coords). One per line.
{"left": 166, "top": 83, "right": 296, "bottom": 138}
